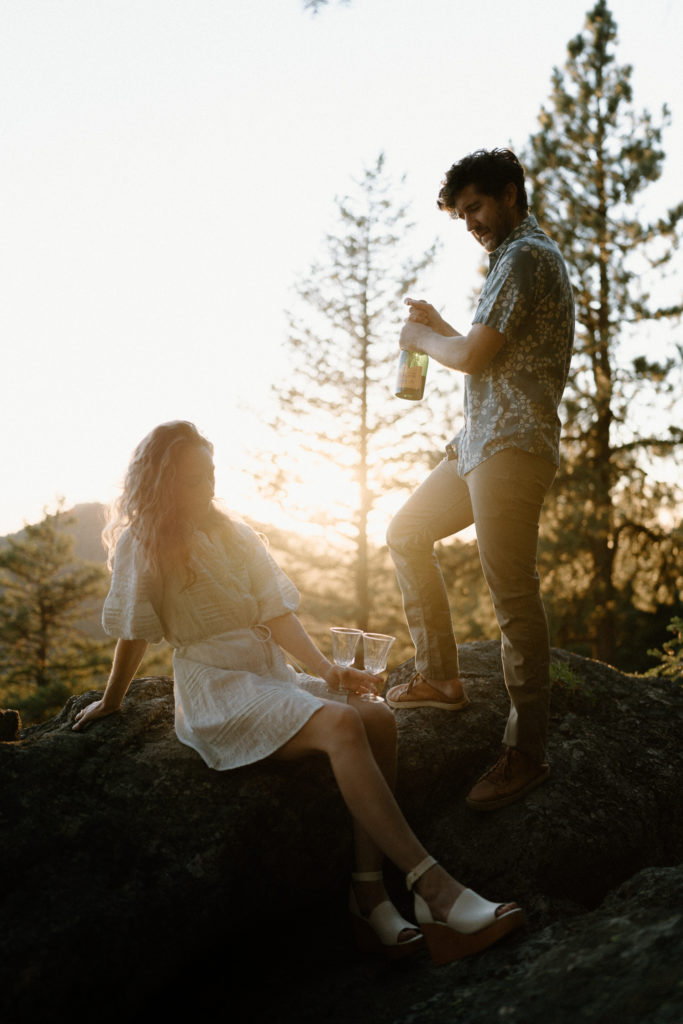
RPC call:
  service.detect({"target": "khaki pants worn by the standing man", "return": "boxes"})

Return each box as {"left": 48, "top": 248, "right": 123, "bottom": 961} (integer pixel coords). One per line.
{"left": 387, "top": 447, "right": 555, "bottom": 761}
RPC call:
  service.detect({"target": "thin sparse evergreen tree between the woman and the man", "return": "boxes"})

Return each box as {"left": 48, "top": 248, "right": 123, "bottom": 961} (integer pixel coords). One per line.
{"left": 266, "top": 156, "right": 454, "bottom": 629}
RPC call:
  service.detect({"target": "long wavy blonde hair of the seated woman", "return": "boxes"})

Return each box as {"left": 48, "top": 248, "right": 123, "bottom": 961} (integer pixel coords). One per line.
{"left": 102, "top": 420, "right": 230, "bottom": 582}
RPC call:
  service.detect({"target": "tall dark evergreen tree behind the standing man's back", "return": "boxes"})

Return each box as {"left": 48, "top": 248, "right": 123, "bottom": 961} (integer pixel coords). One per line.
{"left": 524, "top": 0, "right": 683, "bottom": 664}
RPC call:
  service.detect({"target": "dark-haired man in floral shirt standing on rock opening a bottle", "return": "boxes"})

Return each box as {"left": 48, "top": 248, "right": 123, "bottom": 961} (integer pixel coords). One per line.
{"left": 387, "top": 150, "right": 574, "bottom": 810}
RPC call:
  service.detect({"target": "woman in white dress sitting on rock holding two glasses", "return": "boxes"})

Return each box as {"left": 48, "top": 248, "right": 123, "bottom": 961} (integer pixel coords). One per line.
{"left": 74, "top": 421, "right": 523, "bottom": 963}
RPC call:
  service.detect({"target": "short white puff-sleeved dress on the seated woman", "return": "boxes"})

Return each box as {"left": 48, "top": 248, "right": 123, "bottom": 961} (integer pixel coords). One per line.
{"left": 102, "top": 521, "right": 330, "bottom": 769}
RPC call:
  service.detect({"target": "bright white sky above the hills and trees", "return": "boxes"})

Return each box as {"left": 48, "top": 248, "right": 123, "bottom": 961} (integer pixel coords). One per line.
{"left": 0, "top": 0, "right": 683, "bottom": 535}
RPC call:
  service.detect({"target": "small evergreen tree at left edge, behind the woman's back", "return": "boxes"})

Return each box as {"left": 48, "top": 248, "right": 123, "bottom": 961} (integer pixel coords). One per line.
{"left": 0, "top": 510, "right": 110, "bottom": 719}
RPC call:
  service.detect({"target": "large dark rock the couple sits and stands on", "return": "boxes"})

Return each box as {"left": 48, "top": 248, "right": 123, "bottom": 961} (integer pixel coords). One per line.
{"left": 0, "top": 643, "right": 683, "bottom": 1024}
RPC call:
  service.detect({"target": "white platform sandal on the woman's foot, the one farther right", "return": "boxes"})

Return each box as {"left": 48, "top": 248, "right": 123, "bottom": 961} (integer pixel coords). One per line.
{"left": 405, "top": 857, "right": 525, "bottom": 967}
